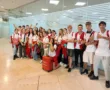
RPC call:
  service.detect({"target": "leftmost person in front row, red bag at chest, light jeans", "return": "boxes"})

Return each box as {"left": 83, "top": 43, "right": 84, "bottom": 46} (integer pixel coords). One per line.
{"left": 12, "top": 29, "right": 19, "bottom": 60}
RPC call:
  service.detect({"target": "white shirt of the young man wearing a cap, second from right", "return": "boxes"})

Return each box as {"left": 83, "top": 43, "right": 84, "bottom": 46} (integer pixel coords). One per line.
{"left": 84, "top": 33, "right": 96, "bottom": 52}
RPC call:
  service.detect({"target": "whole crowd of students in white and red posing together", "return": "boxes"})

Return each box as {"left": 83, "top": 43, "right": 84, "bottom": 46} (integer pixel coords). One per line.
{"left": 11, "top": 21, "right": 110, "bottom": 88}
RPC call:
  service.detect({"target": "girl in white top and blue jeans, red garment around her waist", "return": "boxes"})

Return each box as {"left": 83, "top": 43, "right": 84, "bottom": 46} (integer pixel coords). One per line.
{"left": 32, "top": 30, "right": 38, "bottom": 60}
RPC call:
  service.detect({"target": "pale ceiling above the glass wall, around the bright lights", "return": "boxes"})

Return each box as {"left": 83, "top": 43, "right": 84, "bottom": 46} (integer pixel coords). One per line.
{"left": 0, "top": 0, "right": 110, "bottom": 17}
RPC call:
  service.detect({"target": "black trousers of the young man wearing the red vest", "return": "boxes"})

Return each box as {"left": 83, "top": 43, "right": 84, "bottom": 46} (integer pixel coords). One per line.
{"left": 75, "top": 49, "right": 83, "bottom": 68}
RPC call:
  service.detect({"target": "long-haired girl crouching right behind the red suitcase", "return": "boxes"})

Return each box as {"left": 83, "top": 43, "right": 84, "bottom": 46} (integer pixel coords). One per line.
{"left": 48, "top": 38, "right": 60, "bottom": 69}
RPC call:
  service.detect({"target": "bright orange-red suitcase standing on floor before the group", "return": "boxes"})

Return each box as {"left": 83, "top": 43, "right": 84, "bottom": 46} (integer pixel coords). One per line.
{"left": 42, "top": 56, "right": 53, "bottom": 72}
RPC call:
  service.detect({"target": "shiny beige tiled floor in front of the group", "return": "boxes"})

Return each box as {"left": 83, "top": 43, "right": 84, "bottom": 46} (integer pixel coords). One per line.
{"left": 0, "top": 39, "right": 110, "bottom": 90}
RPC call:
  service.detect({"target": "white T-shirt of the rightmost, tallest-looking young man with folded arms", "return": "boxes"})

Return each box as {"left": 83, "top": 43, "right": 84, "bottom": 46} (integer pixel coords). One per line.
{"left": 94, "top": 31, "right": 110, "bottom": 56}
